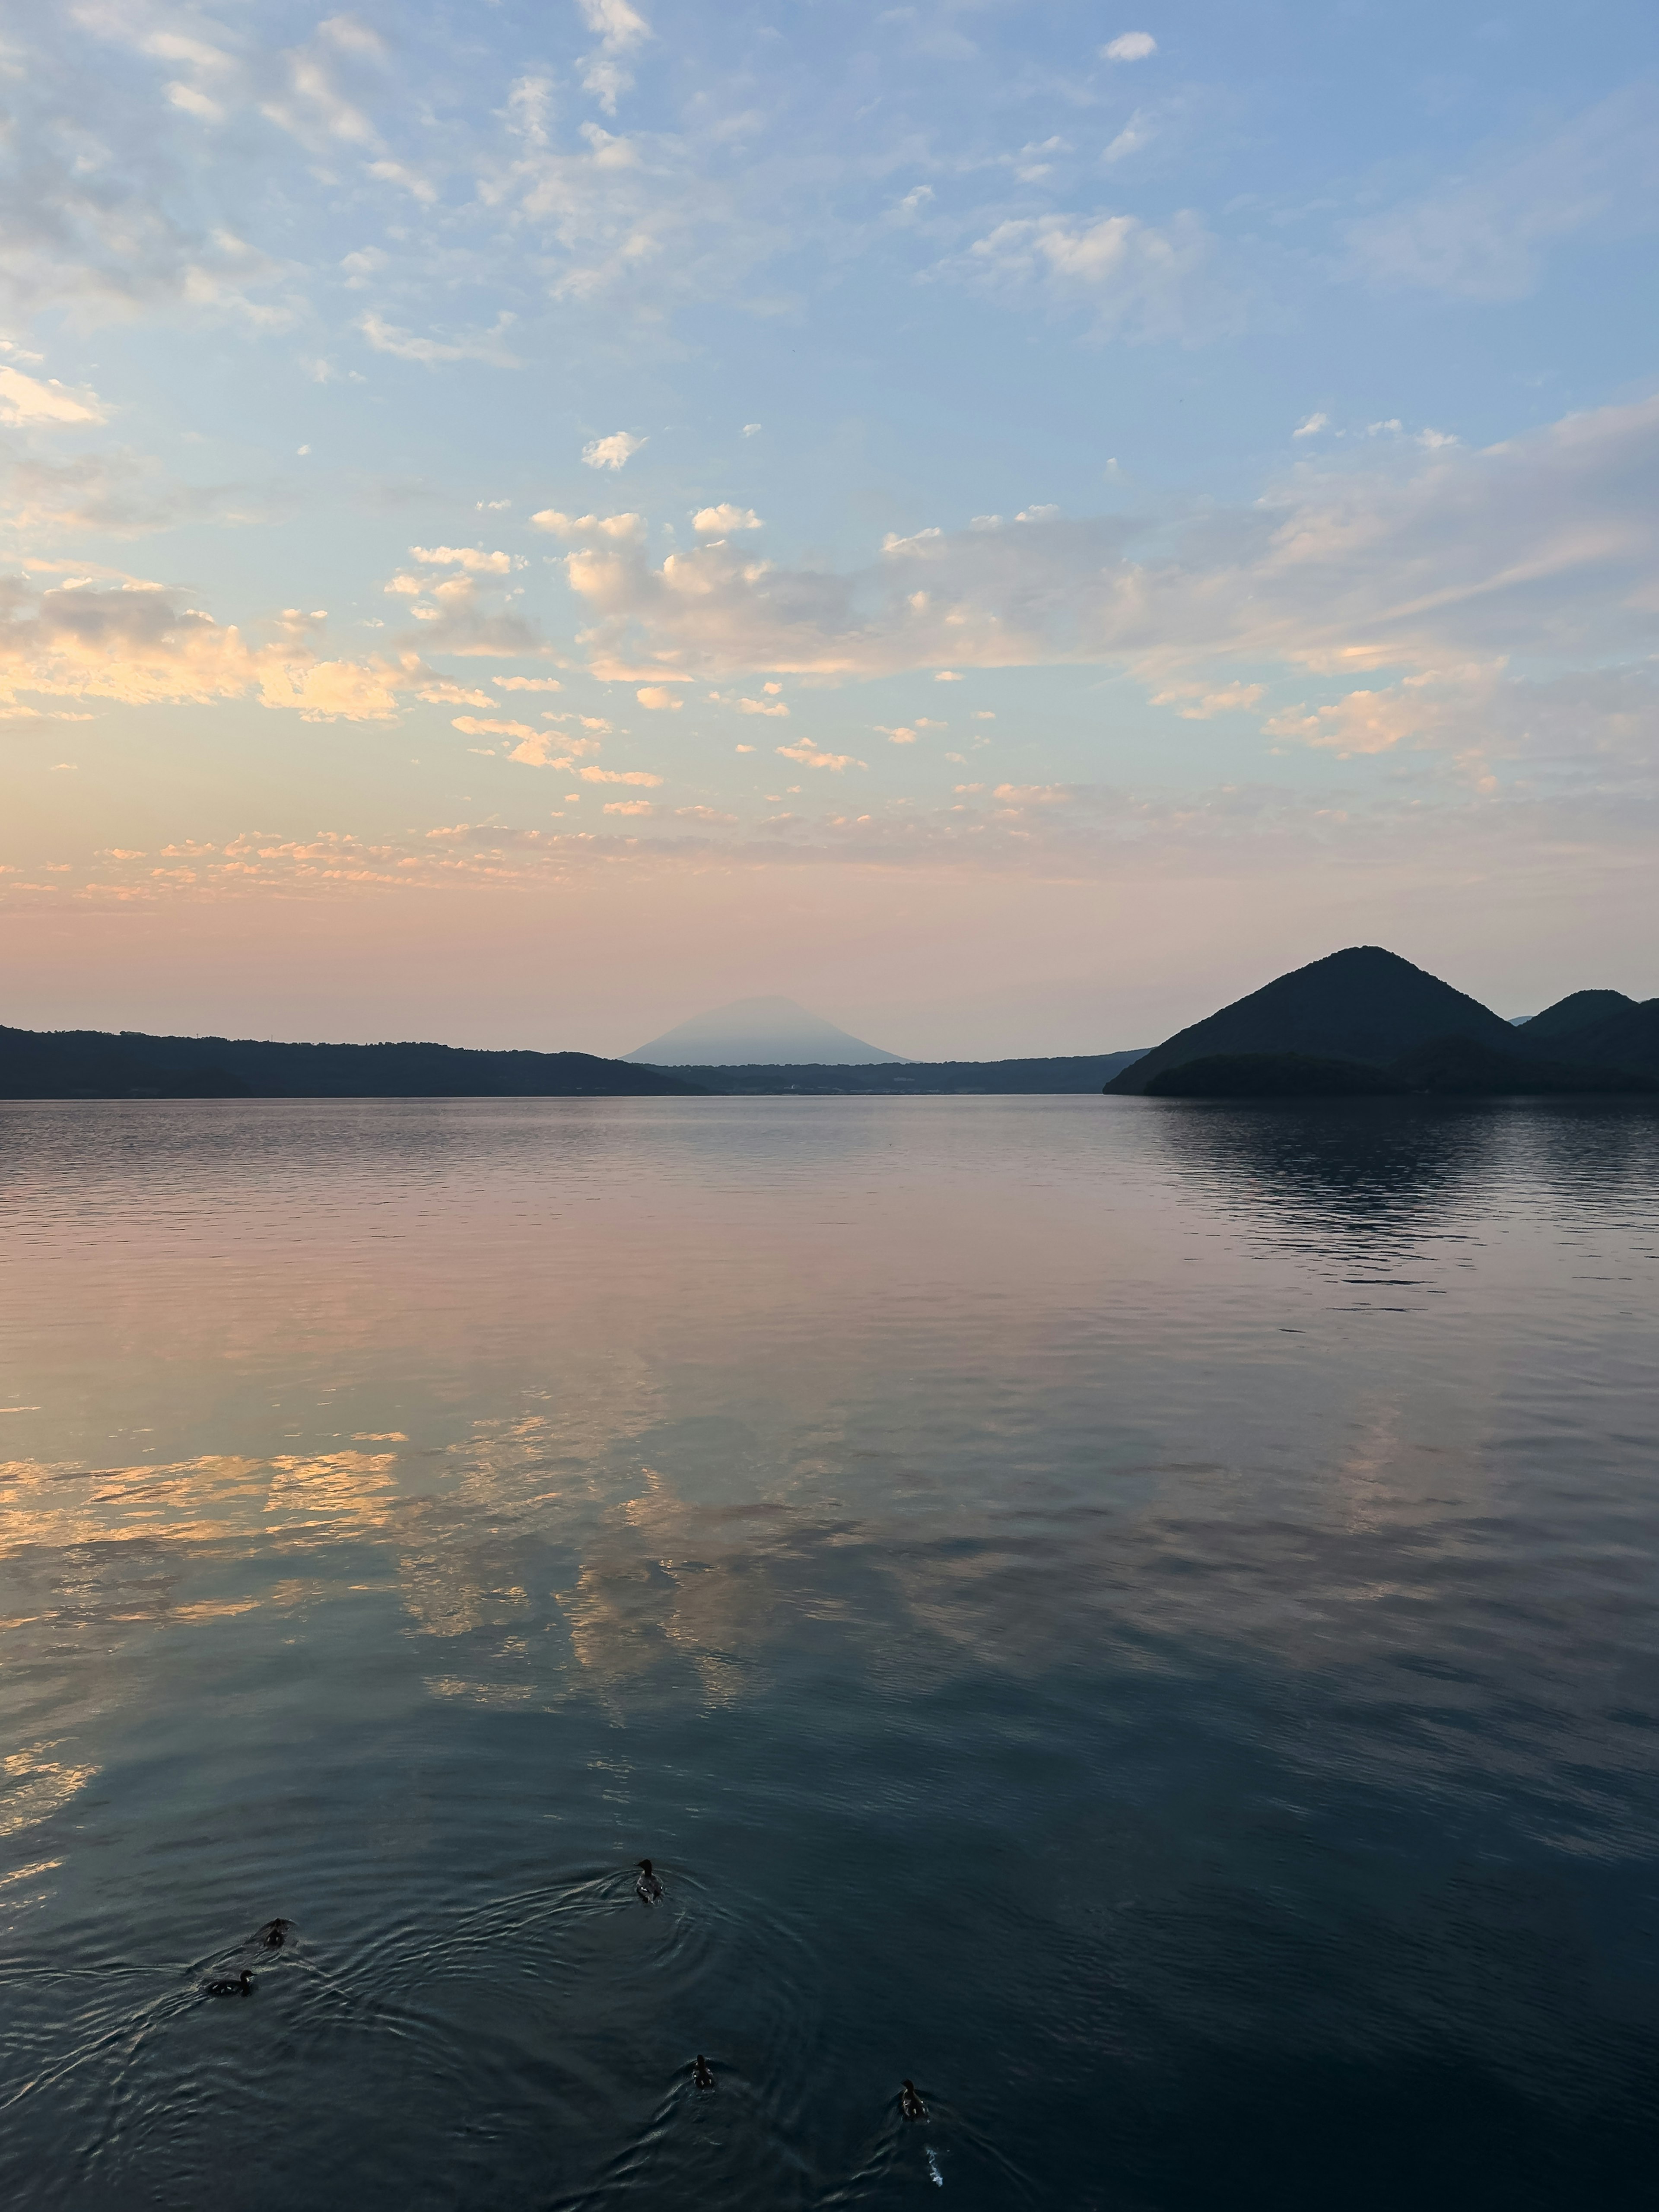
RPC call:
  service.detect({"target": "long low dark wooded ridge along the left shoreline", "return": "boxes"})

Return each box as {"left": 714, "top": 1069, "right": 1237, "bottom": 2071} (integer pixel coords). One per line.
{"left": 0, "top": 1029, "right": 697, "bottom": 1100}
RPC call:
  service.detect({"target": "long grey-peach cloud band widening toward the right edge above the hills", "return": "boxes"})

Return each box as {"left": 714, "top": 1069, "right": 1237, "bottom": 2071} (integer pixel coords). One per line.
{"left": 555, "top": 398, "right": 1659, "bottom": 690}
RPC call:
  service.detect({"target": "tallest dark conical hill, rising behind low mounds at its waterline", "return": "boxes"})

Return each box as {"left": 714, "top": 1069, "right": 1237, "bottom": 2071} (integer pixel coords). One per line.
{"left": 1108, "top": 944, "right": 1522, "bottom": 1093}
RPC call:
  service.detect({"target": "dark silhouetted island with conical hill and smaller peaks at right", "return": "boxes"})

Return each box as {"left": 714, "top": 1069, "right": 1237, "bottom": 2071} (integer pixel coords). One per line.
{"left": 1104, "top": 944, "right": 1659, "bottom": 1097}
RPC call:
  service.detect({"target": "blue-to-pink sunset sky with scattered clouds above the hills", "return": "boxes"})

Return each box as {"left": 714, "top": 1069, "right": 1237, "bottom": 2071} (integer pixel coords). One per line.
{"left": 0, "top": 0, "right": 1659, "bottom": 1057}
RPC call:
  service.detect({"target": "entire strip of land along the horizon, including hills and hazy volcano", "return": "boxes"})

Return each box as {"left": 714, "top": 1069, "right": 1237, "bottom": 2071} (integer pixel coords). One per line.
{"left": 0, "top": 944, "right": 1659, "bottom": 1100}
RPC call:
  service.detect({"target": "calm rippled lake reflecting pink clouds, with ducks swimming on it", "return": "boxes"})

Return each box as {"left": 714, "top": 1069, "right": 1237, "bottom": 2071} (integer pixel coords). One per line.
{"left": 0, "top": 1097, "right": 1659, "bottom": 2212}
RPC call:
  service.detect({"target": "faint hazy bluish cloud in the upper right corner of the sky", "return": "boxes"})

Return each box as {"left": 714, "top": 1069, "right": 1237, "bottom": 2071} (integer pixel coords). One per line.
{"left": 1347, "top": 84, "right": 1659, "bottom": 303}
